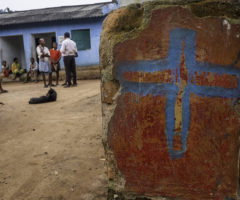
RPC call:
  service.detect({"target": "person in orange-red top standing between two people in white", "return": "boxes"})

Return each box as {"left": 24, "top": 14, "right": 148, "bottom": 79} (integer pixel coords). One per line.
{"left": 50, "top": 42, "right": 62, "bottom": 85}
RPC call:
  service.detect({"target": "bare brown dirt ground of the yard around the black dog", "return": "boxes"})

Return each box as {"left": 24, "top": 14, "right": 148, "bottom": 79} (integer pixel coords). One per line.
{"left": 0, "top": 80, "right": 107, "bottom": 200}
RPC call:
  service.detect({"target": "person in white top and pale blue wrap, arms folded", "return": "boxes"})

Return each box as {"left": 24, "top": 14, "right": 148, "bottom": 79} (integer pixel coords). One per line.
{"left": 37, "top": 38, "right": 54, "bottom": 88}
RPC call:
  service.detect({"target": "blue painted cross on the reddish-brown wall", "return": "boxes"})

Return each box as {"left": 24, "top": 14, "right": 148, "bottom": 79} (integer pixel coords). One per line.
{"left": 117, "top": 28, "right": 240, "bottom": 159}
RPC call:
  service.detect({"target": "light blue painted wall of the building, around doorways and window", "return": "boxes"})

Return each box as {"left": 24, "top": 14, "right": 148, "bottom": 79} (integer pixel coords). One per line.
{"left": 0, "top": 17, "right": 104, "bottom": 69}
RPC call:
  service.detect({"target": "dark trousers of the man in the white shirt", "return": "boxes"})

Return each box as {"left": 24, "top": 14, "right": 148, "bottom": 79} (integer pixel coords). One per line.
{"left": 63, "top": 56, "right": 77, "bottom": 85}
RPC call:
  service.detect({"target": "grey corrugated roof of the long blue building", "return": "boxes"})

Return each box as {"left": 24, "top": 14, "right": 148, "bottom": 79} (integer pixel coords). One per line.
{"left": 0, "top": 2, "right": 111, "bottom": 26}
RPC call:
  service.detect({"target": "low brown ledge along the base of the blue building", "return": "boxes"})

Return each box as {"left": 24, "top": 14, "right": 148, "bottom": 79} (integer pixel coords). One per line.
{"left": 3, "top": 66, "right": 100, "bottom": 83}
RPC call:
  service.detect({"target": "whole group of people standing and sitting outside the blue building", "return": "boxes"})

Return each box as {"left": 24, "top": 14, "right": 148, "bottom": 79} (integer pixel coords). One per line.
{"left": 0, "top": 32, "right": 78, "bottom": 93}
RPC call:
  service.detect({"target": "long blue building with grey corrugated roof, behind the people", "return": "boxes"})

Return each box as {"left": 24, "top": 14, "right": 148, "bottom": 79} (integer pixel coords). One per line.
{"left": 0, "top": 2, "right": 118, "bottom": 68}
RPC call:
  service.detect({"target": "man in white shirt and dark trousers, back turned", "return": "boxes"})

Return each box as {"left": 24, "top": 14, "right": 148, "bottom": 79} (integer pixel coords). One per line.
{"left": 60, "top": 32, "right": 77, "bottom": 88}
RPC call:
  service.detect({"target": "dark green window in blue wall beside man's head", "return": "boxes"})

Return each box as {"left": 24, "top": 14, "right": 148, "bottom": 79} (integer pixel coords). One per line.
{"left": 71, "top": 29, "right": 91, "bottom": 50}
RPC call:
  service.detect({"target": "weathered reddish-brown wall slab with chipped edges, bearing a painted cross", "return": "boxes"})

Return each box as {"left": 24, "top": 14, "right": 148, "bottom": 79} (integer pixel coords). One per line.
{"left": 100, "top": 1, "right": 240, "bottom": 200}
